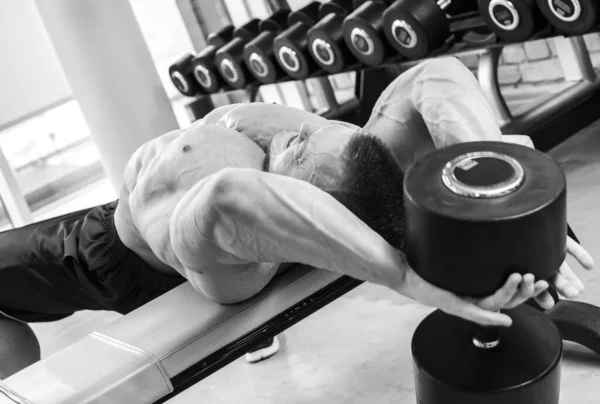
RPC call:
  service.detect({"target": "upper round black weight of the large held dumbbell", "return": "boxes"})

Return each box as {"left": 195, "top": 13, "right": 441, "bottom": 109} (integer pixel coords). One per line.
{"left": 404, "top": 142, "right": 567, "bottom": 297}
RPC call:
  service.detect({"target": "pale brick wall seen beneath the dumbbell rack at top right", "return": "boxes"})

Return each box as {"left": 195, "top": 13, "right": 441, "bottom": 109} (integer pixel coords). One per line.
{"left": 459, "top": 33, "right": 600, "bottom": 88}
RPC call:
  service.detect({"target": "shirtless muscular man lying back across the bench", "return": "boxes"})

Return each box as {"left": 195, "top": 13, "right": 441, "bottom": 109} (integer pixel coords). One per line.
{"left": 0, "top": 58, "right": 593, "bottom": 377}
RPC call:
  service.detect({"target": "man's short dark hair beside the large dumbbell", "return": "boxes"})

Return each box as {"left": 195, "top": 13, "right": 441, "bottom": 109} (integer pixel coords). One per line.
{"left": 329, "top": 132, "right": 406, "bottom": 251}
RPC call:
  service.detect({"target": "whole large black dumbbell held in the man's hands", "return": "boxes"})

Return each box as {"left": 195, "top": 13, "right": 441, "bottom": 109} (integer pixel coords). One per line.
{"left": 403, "top": 141, "right": 568, "bottom": 404}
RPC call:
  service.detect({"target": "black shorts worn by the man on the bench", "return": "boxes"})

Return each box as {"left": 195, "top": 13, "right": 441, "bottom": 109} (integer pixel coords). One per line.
{"left": 0, "top": 201, "right": 186, "bottom": 322}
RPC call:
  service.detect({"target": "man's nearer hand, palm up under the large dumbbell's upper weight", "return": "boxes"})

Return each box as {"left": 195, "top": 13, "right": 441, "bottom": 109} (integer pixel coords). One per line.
{"left": 398, "top": 268, "right": 548, "bottom": 327}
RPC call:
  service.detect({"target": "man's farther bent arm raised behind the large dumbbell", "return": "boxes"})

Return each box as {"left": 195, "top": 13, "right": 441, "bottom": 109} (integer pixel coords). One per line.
{"left": 364, "top": 57, "right": 502, "bottom": 166}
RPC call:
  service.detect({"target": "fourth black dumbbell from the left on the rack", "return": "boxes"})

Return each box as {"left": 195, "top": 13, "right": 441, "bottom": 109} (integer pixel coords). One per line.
{"left": 244, "top": 9, "right": 290, "bottom": 84}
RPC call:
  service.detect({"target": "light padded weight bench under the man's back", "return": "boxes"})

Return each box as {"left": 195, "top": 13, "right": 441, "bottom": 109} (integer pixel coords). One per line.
{"left": 0, "top": 136, "right": 600, "bottom": 404}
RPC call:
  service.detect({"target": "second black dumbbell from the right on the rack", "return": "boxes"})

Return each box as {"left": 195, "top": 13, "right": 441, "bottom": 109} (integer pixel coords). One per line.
{"left": 479, "top": 0, "right": 546, "bottom": 42}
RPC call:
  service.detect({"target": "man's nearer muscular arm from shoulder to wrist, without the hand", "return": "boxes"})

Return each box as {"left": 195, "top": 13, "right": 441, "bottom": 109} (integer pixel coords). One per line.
{"left": 170, "top": 169, "right": 408, "bottom": 290}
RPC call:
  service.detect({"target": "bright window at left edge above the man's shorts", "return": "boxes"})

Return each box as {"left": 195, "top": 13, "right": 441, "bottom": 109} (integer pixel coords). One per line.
{"left": 0, "top": 101, "right": 115, "bottom": 224}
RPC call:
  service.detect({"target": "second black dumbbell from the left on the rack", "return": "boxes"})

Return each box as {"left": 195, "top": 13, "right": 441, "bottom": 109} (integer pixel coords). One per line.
{"left": 192, "top": 25, "right": 234, "bottom": 93}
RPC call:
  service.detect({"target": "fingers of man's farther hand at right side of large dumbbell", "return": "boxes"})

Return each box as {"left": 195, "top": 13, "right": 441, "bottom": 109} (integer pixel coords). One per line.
{"left": 535, "top": 237, "right": 594, "bottom": 310}
